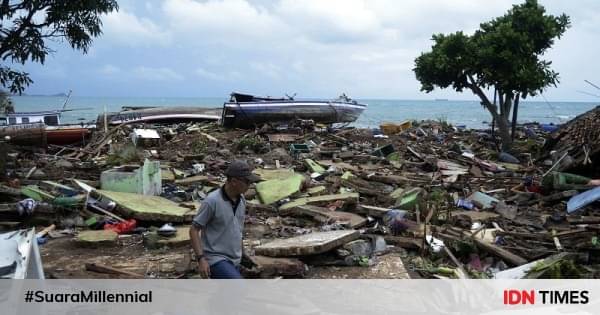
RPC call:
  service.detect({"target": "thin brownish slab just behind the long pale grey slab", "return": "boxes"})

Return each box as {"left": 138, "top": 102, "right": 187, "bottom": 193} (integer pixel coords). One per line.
{"left": 279, "top": 205, "right": 367, "bottom": 228}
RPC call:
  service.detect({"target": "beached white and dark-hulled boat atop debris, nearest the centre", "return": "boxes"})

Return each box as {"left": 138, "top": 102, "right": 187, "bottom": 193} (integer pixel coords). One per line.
{"left": 221, "top": 92, "right": 367, "bottom": 128}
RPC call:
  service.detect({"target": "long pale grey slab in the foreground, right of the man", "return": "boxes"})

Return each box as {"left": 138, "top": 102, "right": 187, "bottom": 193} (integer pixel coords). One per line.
{"left": 255, "top": 230, "right": 360, "bottom": 257}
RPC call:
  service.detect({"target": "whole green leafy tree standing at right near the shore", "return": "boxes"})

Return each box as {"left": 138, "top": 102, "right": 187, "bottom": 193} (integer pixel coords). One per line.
{"left": 413, "top": 0, "right": 570, "bottom": 150}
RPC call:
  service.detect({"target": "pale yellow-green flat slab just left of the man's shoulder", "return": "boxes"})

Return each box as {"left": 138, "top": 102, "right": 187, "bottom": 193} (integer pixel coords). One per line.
{"left": 97, "top": 190, "right": 195, "bottom": 222}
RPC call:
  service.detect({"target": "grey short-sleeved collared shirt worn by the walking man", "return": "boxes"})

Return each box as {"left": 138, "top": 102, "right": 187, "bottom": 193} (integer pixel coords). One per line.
{"left": 192, "top": 187, "right": 246, "bottom": 266}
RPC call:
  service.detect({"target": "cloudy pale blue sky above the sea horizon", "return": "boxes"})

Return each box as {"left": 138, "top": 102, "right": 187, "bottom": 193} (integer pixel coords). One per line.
{"left": 16, "top": 0, "right": 600, "bottom": 101}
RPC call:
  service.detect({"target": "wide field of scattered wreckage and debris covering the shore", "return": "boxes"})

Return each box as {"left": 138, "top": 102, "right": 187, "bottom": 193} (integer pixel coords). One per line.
{"left": 0, "top": 111, "right": 600, "bottom": 278}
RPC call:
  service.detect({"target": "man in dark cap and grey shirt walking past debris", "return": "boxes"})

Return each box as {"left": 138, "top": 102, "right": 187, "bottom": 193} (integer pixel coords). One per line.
{"left": 190, "top": 161, "right": 260, "bottom": 279}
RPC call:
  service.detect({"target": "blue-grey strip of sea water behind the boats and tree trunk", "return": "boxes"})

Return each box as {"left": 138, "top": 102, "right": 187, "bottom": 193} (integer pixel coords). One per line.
{"left": 12, "top": 96, "right": 600, "bottom": 128}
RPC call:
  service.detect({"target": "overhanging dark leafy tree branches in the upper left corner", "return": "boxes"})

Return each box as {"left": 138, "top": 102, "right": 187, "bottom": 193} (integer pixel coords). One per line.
{"left": 0, "top": 0, "right": 119, "bottom": 93}
